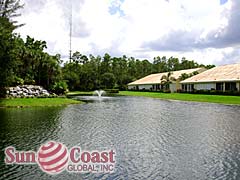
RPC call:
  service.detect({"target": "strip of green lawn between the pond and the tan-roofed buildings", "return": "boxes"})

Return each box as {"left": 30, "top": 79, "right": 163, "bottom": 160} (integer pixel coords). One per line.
{"left": 119, "top": 91, "right": 240, "bottom": 105}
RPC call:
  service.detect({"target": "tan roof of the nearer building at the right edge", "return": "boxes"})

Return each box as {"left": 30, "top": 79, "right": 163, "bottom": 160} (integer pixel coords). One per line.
{"left": 181, "top": 64, "right": 240, "bottom": 83}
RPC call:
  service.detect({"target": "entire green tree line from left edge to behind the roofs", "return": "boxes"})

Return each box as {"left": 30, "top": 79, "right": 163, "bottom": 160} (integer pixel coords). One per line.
{"left": 0, "top": 0, "right": 213, "bottom": 96}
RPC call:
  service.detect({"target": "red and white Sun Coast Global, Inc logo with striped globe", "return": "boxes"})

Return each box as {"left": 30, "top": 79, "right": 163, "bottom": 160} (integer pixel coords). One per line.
{"left": 5, "top": 141, "right": 116, "bottom": 175}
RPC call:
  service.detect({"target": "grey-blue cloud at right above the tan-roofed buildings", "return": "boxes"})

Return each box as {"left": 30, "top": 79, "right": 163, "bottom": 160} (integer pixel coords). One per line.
{"left": 142, "top": 1, "right": 240, "bottom": 51}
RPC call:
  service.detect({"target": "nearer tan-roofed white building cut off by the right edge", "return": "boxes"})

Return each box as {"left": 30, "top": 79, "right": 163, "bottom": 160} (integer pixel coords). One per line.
{"left": 181, "top": 64, "right": 240, "bottom": 92}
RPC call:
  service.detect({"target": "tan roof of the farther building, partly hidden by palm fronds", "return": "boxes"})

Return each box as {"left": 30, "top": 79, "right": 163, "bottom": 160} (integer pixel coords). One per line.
{"left": 128, "top": 68, "right": 205, "bottom": 85}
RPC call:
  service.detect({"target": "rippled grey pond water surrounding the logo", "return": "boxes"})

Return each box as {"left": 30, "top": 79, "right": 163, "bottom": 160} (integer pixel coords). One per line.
{"left": 0, "top": 97, "right": 240, "bottom": 180}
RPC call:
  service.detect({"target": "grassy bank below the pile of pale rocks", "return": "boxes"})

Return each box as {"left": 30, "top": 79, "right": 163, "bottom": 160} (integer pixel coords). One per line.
{"left": 0, "top": 98, "right": 81, "bottom": 107}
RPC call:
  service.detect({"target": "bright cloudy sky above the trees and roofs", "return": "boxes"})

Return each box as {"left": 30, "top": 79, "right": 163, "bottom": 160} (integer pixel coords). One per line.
{"left": 17, "top": 0, "right": 240, "bottom": 65}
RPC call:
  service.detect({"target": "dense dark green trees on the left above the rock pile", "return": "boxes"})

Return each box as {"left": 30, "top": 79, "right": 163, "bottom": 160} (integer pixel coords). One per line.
{"left": 0, "top": 0, "right": 62, "bottom": 96}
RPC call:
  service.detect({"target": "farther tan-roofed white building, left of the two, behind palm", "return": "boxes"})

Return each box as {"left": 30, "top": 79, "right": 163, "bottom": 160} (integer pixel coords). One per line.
{"left": 128, "top": 68, "right": 206, "bottom": 92}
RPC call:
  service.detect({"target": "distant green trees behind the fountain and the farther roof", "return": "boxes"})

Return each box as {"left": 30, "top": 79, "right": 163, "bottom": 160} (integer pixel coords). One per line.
{"left": 62, "top": 52, "right": 214, "bottom": 90}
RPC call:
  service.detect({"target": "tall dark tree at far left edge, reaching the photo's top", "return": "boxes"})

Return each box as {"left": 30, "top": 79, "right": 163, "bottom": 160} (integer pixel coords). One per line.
{"left": 0, "top": 0, "right": 22, "bottom": 97}
